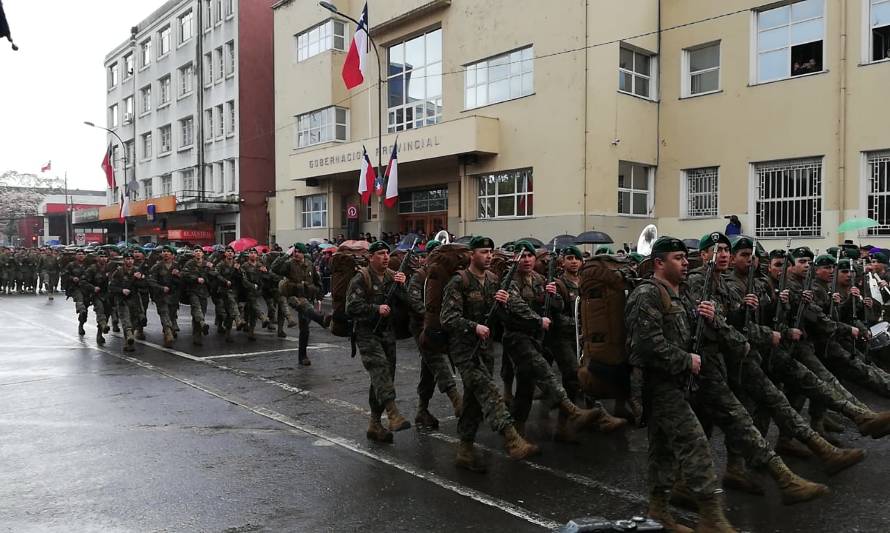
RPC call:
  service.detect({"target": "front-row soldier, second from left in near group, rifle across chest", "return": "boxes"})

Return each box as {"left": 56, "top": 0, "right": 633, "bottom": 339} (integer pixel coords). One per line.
{"left": 440, "top": 237, "right": 540, "bottom": 472}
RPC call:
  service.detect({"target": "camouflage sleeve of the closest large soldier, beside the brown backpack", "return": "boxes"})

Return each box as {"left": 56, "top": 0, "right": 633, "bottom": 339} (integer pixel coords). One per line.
{"left": 625, "top": 284, "right": 692, "bottom": 375}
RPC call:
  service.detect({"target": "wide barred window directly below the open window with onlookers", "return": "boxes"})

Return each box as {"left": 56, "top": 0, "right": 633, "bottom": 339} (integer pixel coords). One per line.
{"left": 754, "top": 158, "right": 822, "bottom": 238}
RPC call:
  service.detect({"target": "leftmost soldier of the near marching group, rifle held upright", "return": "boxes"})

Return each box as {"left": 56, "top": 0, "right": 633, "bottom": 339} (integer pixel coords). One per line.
{"left": 346, "top": 241, "right": 411, "bottom": 442}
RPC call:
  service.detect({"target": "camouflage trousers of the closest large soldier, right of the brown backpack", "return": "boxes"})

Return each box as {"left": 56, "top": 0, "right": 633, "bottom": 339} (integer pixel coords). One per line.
{"left": 647, "top": 383, "right": 720, "bottom": 495}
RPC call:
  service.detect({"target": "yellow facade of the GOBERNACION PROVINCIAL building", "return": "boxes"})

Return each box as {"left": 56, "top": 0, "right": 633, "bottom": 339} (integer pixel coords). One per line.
{"left": 270, "top": 0, "right": 890, "bottom": 248}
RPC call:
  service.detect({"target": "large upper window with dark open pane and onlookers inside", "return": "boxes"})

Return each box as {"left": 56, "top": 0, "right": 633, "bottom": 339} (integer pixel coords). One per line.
{"left": 756, "top": 0, "right": 825, "bottom": 83}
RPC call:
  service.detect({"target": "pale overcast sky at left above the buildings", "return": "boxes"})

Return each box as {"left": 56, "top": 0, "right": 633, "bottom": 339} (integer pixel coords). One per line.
{"left": 0, "top": 0, "right": 158, "bottom": 189}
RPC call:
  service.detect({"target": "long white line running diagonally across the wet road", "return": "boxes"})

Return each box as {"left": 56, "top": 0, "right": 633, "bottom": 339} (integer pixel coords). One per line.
{"left": 0, "top": 310, "right": 561, "bottom": 529}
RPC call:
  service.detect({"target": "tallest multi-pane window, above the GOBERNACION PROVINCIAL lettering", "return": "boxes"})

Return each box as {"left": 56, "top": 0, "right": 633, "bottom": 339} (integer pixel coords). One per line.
{"left": 386, "top": 29, "right": 442, "bottom": 132}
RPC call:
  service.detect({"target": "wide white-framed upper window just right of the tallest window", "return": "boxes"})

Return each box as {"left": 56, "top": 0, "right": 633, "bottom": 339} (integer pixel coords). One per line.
{"left": 464, "top": 46, "right": 535, "bottom": 109}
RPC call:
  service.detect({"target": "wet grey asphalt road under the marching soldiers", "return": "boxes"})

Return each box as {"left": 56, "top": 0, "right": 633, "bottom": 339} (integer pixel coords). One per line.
{"left": 0, "top": 296, "right": 890, "bottom": 532}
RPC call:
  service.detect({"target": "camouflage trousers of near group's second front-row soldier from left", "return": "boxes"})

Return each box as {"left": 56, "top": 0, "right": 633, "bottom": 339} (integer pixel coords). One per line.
{"left": 451, "top": 342, "right": 513, "bottom": 441}
